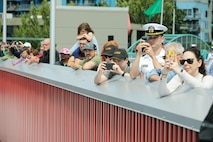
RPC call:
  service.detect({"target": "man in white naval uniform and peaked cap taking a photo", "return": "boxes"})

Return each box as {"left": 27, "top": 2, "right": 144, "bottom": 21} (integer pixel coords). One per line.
{"left": 130, "top": 23, "right": 168, "bottom": 80}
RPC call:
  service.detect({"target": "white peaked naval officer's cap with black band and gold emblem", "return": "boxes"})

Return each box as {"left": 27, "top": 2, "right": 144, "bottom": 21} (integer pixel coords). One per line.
{"left": 143, "top": 23, "right": 168, "bottom": 36}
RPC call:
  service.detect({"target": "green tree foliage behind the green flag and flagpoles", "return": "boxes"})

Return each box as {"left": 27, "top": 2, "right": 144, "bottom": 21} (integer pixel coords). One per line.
{"left": 117, "top": 0, "right": 185, "bottom": 33}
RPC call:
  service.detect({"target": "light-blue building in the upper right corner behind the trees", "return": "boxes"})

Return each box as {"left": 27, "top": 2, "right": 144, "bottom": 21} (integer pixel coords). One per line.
{"left": 176, "top": 0, "right": 212, "bottom": 42}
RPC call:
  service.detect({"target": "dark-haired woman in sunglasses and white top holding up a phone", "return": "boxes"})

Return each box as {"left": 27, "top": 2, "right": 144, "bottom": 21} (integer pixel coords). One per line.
{"left": 159, "top": 48, "right": 213, "bottom": 96}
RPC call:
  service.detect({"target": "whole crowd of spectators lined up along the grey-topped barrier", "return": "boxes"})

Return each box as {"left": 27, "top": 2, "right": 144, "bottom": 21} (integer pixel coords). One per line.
{"left": 0, "top": 23, "right": 213, "bottom": 96}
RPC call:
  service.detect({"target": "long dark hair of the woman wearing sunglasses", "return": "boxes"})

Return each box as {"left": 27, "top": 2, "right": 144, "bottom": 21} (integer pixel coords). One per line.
{"left": 183, "top": 47, "right": 206, "bottom": 76}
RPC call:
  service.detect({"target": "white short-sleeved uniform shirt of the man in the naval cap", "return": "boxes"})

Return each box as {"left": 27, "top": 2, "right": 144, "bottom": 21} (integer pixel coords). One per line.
{"left": 139, "top": 49, "right": 165, "bottom": 74}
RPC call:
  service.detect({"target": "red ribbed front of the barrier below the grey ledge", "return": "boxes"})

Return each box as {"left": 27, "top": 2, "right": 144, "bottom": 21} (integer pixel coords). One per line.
{"left": 0, "top": 71, "right": 198, "bottom": 142}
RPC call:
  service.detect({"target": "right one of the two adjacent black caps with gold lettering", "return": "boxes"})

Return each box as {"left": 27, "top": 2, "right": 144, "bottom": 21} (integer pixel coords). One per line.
{"left": 112, "top": 48, "right": 128, "bottom": 60}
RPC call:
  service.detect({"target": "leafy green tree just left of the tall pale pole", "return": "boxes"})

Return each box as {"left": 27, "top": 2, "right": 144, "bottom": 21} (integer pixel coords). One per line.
{"left": 13, "top": 0, "right": 50, "bottom": 48}
